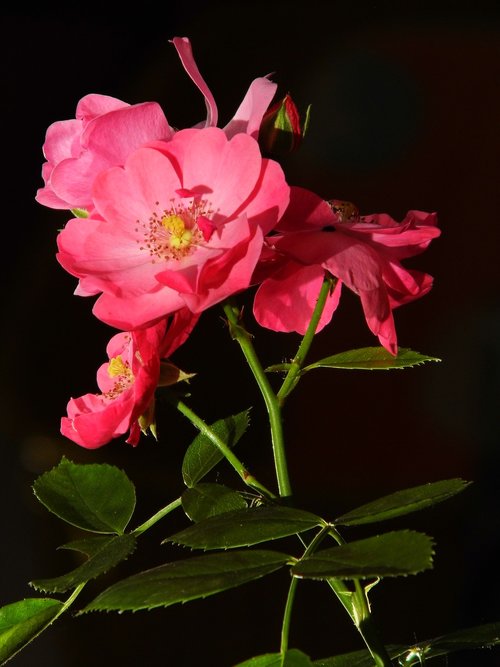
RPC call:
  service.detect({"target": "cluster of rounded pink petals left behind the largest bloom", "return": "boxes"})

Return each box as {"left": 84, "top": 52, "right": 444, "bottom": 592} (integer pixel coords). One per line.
{"left": 36, "top": 95, "right": 173, "bottom": 209}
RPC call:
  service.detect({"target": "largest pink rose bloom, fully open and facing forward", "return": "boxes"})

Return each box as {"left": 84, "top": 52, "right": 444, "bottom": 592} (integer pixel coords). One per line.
{"left": 57, "top": 127, "right": 290, "bottom": 330}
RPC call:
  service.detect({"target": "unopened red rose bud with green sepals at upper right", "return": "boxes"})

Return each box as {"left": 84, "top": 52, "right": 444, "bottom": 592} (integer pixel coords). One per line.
{"left": 259, "top": 94, "right": 311, "bottom": 155}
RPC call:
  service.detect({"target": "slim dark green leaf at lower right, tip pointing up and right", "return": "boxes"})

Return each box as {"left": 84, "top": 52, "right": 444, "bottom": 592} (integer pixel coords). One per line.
{"left": 334, "top": 479, "right": 471, "bottom": 526}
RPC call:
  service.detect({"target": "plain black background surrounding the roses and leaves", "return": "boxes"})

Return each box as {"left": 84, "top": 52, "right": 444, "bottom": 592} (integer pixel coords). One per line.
{"left": 0, "top": 0, "right": 500, "bottom": 667}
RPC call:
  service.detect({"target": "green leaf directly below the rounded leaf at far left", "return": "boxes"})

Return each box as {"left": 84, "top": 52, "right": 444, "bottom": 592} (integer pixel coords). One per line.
{"left": 31, "top": 535, "right": 136, "bottom": 593}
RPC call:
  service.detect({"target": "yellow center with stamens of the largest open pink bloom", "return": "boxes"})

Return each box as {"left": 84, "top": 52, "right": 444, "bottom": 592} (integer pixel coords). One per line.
{"left": 135, "top": 197, "right": 215, "bottom": 264}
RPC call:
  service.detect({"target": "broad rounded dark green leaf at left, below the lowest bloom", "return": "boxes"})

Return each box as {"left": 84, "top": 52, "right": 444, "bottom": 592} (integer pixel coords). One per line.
{"left": 33, "top": 458, "right": 135, "bottom": 535}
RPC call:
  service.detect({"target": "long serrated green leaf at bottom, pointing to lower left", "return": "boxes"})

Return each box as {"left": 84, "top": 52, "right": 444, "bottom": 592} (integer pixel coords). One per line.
{"left": 82, "top": 550, "right": 290, "bottom": 613}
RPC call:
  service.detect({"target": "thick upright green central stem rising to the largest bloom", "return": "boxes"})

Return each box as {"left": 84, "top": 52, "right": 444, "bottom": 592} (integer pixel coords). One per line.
{"left": 224, "top": 302, "right": 292, "bottom": 498}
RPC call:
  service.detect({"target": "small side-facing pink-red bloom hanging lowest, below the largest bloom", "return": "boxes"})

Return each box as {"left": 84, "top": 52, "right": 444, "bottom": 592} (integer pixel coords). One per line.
{"left": 61, "top": 310, "right": 197, "bottom": 449}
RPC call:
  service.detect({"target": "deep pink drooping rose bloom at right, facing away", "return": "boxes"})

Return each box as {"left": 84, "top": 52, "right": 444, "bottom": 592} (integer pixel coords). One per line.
{"left": 254, "top": 188, "right": 440, "bottom": 355}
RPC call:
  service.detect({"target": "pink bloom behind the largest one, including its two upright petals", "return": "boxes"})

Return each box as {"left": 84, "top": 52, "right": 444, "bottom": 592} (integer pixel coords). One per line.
{"left": 36, "top": 37, "right": 277, "bottom": 210}
